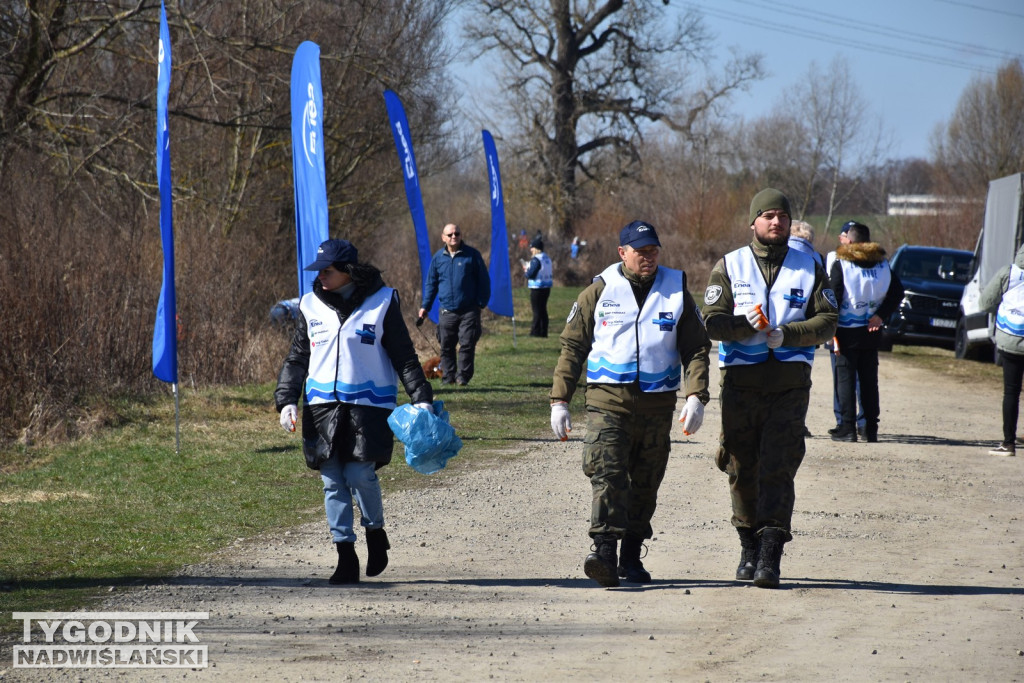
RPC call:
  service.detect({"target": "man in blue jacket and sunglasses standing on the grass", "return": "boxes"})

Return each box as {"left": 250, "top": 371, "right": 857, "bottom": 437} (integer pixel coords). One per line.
{"left": 419, "top": 223, "right": 490, "bottom": 385}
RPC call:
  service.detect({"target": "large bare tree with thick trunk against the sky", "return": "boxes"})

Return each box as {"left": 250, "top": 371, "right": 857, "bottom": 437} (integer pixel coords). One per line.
{"left": 467, "top": 0, "right": 762, "bottom": 237}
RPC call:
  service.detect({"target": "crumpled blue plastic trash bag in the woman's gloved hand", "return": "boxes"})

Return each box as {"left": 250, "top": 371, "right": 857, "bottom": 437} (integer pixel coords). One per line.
{"left": 387, "top": 400, "right": 462, "bottom": 474}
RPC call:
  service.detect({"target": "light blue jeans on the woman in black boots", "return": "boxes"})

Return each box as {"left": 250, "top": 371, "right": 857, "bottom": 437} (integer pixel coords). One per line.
{"left": 319, "top": 457, "right": 384, "bottom": 543}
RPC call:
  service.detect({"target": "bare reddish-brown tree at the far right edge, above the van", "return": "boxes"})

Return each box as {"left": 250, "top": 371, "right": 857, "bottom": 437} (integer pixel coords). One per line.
{"left": 932, "top": 59, "right": 1024, "bottom": 197}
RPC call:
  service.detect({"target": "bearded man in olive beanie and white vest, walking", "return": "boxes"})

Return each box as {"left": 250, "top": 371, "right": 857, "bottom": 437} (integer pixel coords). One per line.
{"left": 703, "top": 187, "right": 838, "bottom": 588}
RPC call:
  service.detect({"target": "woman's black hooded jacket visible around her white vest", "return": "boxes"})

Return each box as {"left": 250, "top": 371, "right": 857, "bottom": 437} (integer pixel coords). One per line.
{"left": 273, "top": 272, "right": 433, "bottom": 469}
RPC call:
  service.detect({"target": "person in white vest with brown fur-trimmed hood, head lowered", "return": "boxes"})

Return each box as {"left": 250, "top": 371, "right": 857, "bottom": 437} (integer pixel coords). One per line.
{"left": 828, "top": 222, "right": 903, "bottom": 442}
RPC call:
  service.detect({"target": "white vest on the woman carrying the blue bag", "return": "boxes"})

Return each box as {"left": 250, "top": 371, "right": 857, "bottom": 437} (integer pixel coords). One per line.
{"left": 299, "top": 287, "right": 398, "bottom": 409}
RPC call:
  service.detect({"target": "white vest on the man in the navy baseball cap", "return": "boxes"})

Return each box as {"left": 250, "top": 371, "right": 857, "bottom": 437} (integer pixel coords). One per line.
{"left": 587, "top": 263, "right": 684, "bottom": 392}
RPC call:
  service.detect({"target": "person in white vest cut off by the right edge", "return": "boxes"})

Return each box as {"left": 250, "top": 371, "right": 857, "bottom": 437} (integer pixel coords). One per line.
{"left": 978, "top": 245, "right": 1024, "bottom": 456}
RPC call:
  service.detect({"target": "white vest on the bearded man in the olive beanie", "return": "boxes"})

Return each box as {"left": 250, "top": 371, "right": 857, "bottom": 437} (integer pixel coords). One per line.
{"left": 718, "top": 247, "right": 815, "bottom": 368}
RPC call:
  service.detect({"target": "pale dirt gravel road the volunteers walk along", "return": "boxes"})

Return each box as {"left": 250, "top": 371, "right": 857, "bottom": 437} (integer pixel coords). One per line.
{"left": 0, "top": 351, "right": 1024, "bottom": 681}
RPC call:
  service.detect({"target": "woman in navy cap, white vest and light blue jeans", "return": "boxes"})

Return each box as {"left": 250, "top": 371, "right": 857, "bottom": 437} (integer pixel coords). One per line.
{"left": 273, "top": 240, "right": 433, "bottom": 584}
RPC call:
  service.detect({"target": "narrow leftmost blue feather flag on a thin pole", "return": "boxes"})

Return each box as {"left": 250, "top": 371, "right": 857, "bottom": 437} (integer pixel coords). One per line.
{"left": 153, "top": 2, "right": 178, "bottom": 384}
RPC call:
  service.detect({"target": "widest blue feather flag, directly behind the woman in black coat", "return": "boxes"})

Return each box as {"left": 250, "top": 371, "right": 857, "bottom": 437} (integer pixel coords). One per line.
{"left": 291, "top": 40, "right": 328, "bottom": 297}
